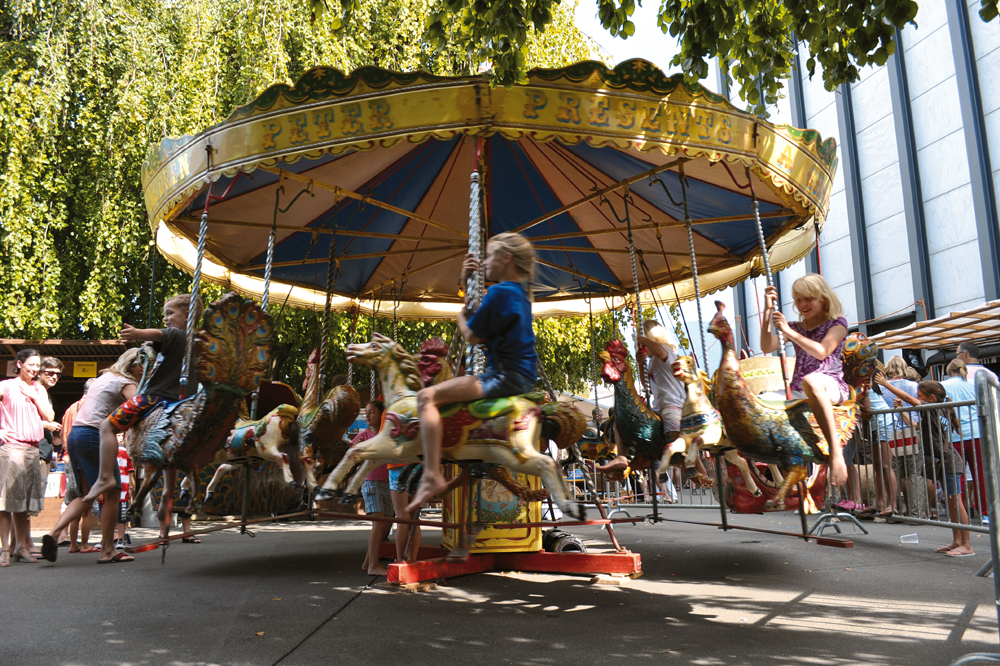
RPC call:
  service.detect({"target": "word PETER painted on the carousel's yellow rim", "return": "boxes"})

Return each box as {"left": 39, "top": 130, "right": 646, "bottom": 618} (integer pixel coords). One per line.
{"left": 261, "top": 99, "right": 395, "bottom": 150}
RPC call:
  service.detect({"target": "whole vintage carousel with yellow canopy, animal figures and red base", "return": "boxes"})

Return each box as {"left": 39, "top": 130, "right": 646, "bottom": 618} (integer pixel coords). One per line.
{"left": 129, "top": 60, "right": 869, "bottom": 583}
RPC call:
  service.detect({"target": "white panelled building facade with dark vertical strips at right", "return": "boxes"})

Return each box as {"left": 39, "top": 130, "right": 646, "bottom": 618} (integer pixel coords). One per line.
{"left": 719, "top": 0, "right": 1000, "bottom": 360}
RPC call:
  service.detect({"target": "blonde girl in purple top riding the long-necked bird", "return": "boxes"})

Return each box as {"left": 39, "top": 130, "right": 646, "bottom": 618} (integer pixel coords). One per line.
{"left": 760, "top": 274, "right": 850, "bottom": 486}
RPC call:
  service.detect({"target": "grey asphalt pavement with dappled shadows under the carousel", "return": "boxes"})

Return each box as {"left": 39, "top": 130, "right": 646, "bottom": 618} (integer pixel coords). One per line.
{"left": 0, "top": 509, "right": 1000, "bottom": 666}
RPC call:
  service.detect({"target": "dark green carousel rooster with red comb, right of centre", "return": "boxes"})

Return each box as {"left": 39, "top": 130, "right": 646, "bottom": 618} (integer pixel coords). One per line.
{"left": 598, "top": 340, "right": 715, "bottom": 488}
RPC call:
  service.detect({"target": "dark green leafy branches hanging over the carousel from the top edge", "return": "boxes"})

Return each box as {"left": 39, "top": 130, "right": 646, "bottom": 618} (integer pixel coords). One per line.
{"left": 322, "top": 0, "right": 998, "bottom": 113}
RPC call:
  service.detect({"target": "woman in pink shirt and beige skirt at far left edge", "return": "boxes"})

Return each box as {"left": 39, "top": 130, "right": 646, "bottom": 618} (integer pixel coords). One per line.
{"left": 0, "top": 349, "right": 55, "bottom": 567}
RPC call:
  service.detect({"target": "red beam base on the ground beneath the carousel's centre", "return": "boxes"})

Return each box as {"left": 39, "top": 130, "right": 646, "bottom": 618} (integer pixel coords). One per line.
{"left": 379, "top": 543, "right": 642, "bottom": 585}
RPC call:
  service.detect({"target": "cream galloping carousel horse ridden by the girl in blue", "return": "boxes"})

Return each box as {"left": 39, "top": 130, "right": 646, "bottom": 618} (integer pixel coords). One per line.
{"left": 316, "top": 333, "right": 584, "bottom": 517}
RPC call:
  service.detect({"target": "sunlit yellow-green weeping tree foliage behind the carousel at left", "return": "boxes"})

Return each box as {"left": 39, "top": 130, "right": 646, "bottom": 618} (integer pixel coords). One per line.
{"left": 0, "top": 0, "right": 592, "bottom": 388}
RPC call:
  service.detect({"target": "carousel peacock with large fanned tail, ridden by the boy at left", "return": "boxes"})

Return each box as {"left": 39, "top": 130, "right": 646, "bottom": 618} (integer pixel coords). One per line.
{"left": 125, "top": 292, "right": 272, "bottom": 518}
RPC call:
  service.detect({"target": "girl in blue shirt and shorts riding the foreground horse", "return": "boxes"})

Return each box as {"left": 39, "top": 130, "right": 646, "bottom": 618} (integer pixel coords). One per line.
{"left": 406, "top": 233, "right": 538, "bottom": 511}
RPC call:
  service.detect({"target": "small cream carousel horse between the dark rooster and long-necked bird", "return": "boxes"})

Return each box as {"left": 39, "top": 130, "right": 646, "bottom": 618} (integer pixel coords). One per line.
{"left": 660, "top": 356, "right": 781, "bottom": 497}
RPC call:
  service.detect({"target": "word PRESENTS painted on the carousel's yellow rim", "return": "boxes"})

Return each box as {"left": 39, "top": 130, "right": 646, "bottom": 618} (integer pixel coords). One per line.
{"left": 522, "top": 90, "right": 733, "bottom": 145}
